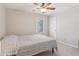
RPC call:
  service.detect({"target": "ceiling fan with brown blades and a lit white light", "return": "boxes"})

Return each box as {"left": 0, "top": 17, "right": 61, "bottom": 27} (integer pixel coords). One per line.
{"left": 34, "top": 3, "right": 56, "bottom": 12}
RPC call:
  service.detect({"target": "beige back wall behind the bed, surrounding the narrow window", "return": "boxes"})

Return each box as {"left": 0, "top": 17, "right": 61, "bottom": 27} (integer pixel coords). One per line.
{"left": 7, "top": 9, "right": 48, "bottom": 35}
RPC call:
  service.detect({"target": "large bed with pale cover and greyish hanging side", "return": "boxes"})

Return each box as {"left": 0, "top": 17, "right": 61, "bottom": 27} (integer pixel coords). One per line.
{"left": 1, "top": 34, "right": 57, "bottom": 56}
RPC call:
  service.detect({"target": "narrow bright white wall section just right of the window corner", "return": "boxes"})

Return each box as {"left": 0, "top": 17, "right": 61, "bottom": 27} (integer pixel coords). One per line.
{"left": 49, "top": 15, "right": 56, "bottom": 39}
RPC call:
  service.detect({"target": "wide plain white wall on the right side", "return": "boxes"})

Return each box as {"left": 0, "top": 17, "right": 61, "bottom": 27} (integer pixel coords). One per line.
{"left": 57, "top": 6, "right": 79, "bottom": 48}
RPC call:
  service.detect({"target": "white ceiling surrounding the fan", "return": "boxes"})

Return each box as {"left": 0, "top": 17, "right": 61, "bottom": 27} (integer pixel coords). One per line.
{"left": 1, "top": 3, "right": 79, "bottom": 15}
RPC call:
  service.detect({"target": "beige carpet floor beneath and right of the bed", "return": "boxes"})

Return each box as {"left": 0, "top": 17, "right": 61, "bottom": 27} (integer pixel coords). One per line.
{"left": 36, "top": 43, "right": 79, "bottom": 56}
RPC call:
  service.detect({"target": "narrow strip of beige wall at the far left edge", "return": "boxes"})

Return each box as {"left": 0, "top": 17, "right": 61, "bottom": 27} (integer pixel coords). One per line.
{"left": 0, "top": 6, "right": 5, "bottom": 55}
